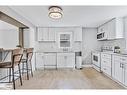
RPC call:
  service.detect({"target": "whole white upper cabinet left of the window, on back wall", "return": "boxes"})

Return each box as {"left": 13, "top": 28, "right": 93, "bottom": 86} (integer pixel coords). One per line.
{"left": 37, "top": 28, "right": 55, "bottom": 41}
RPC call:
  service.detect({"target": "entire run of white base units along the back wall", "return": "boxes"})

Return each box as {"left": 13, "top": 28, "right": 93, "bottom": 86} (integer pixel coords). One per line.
{"left": 36, "top": 52, "right": 75, "bottom": 69}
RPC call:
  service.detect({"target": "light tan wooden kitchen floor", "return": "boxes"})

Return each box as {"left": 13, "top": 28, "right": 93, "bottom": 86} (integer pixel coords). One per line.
{"left": 16, "top": 68, "right": 124, "bottom": 89}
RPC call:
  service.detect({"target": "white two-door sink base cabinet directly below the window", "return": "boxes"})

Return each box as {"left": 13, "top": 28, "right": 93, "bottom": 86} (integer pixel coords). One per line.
{"left": 57, "top": 53, "right": 75, "bottom": 69}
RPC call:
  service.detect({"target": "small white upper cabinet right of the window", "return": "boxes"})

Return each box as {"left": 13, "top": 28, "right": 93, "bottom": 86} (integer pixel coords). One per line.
{"left": 74, "top": 27, "right": 82, "bottom": 42}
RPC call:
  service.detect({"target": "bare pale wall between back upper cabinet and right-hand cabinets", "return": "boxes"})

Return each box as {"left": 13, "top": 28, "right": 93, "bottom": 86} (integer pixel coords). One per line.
{"left": 82, "top": 28, "right": 101, "bottom": 65}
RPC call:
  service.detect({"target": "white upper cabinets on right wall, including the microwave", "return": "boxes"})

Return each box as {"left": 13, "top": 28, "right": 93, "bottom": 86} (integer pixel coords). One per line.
{"left": 97, "top": 18, "right": 124, "bottom": 40}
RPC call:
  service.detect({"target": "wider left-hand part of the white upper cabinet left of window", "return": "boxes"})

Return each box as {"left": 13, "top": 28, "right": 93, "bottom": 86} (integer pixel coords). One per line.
{"left": 38, "top": 28, "right": 49, "bottom": 41}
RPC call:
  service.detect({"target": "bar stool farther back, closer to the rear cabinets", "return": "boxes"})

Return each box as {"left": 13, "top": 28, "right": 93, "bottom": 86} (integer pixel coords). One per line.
{"left": 21, "top": 48, "right": 34, "bottom": 80}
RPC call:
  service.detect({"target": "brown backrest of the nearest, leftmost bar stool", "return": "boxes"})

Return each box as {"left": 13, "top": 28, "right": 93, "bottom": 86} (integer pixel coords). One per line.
{"left": 12, "top": 49, "right": 23, "bottom": 66}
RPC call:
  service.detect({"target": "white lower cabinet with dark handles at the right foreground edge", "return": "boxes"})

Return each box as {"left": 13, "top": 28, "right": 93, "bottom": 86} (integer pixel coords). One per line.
{"left": 112, "top": 55, "right": 127, "bottom": 86}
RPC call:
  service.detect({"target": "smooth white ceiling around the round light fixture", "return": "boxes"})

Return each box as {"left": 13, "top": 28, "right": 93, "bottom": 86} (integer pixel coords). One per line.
{"left": 10, "top": 6, "right": 127, "bottom": 27}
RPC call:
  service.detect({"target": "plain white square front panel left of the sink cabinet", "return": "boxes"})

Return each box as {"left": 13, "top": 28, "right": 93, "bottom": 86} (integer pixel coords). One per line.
{"left": 44, "top": 53, "right": 56, "bottom": 66}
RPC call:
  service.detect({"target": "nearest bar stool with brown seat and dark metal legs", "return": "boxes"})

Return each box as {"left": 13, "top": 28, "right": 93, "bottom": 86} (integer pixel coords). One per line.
{"left": 0, "top": 49, "right": 23, "bottom": 89}
